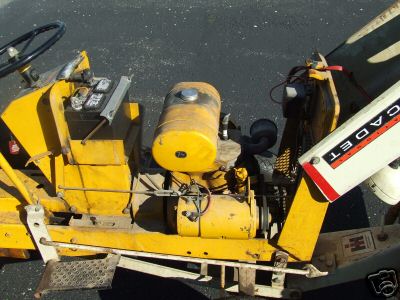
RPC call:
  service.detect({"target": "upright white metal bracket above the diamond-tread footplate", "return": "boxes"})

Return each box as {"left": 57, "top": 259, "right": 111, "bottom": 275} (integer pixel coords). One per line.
{"left": 25, "top": 204, "right": 60, "bottom": 263}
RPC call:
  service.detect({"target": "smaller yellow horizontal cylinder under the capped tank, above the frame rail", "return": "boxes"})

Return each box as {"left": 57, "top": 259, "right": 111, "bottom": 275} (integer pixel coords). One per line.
{"left": 176, "top": 193, "right": 259, "bottom": 239}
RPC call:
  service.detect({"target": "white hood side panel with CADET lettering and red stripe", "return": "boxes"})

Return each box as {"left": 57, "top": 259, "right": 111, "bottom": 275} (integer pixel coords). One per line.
{"left": 299, "top": 81, "right": 400, "bottom": 201}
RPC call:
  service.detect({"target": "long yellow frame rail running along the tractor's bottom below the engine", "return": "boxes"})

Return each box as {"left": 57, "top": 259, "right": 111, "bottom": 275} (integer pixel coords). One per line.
{"left": 0, "top": 219, "right": 294, "bottom": 261}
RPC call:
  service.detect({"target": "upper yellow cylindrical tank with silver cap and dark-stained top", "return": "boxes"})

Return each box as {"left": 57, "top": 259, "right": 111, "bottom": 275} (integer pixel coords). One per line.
{"left": 152, "top": 82, "right": 221, "bottom": 172}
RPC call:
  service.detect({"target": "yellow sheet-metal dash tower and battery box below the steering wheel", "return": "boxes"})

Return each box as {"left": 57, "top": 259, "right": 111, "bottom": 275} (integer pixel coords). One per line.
{"left": 0, "top": 52, "right": 139, "bottom": 215}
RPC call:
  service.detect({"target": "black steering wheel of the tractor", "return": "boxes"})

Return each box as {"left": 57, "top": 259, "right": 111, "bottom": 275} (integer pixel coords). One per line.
{"left": 0, "top": 21, "right": 65, "bottom": 78}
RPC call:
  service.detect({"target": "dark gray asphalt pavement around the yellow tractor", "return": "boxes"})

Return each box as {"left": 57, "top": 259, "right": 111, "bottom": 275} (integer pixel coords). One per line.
{"left": 0, "top": 0, "right": 393, "bottom": 299}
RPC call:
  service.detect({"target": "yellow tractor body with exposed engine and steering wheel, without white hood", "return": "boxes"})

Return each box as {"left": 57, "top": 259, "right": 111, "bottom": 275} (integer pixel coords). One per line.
{"left": 0, "top": 2, "right": 398, "bottom": 298}
